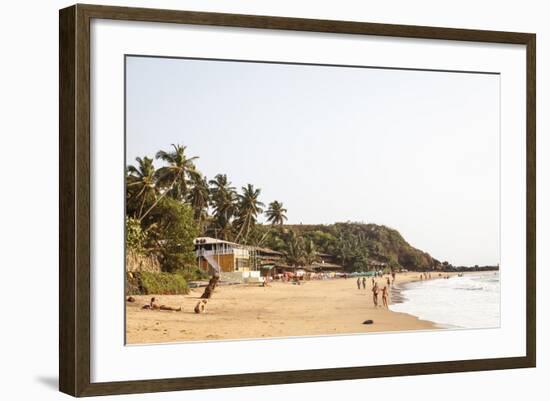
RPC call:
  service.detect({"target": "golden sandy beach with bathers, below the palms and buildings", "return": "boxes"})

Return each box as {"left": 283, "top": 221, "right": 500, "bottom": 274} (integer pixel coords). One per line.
{"left": 126, "top": 273, "right": 460, "bottom": 344}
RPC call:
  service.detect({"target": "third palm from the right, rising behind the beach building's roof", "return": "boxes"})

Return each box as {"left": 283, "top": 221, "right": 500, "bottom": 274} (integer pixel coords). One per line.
{"left": 209, "top": 174, "right": 237, "bottom": 240}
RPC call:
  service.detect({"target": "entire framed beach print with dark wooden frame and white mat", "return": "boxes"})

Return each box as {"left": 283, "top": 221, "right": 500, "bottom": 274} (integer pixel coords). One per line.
{"left": 59, "top": 5, "right": 536, "bottom": 396}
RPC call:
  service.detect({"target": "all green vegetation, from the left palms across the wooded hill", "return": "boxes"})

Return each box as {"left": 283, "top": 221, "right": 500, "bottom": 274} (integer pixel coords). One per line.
{"left": 126, "top": 141, "right": 440, "bottom": 279}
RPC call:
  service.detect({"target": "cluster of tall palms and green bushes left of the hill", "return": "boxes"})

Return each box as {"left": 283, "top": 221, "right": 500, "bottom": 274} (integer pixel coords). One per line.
{"left": 126, "top": 145, "right": 286, "bottom": 278}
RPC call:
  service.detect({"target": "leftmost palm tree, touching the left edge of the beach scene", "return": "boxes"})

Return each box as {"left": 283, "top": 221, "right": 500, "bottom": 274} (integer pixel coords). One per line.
{"left": 126, "top": 157, "right": 158, "bottom": 220}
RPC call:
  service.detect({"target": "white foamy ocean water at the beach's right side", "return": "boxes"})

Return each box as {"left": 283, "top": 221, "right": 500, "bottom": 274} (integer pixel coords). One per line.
{"left": 390, "top": 272, "right": 500, "bottom": 329}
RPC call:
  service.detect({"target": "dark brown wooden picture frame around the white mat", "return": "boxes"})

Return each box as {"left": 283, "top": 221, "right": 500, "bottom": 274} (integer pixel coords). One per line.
{"left": 59, "top": 4, "right": 536, "bottom": 396}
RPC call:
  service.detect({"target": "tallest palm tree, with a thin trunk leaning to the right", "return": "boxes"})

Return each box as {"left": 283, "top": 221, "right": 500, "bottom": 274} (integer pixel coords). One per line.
{"left": 140, "top": 144, "right": 200, "bottom": 219}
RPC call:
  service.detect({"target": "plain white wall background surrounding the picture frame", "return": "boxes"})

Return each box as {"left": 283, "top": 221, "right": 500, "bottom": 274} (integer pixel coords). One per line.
{"left": 0, "top": 0, "right": 550, "bottom": 401}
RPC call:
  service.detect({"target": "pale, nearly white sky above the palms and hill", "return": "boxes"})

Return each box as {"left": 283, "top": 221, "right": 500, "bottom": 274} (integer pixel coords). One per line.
{"left": 126, "top": 57, "right": 500, "bottom": 265}
